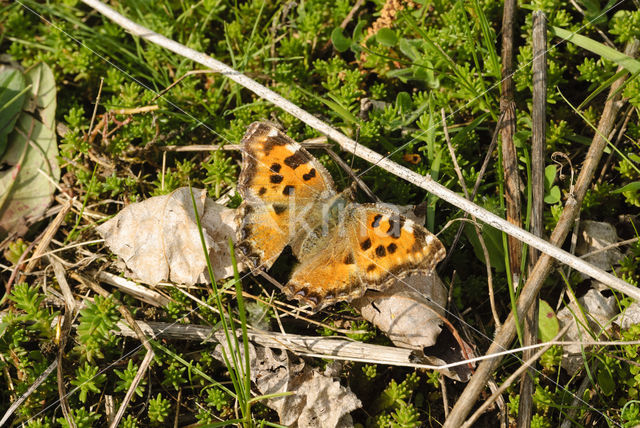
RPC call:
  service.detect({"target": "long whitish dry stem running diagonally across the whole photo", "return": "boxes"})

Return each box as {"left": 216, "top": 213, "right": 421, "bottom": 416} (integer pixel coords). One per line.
{"left": 82, "top": 0, "right": 640, "bottom": 300}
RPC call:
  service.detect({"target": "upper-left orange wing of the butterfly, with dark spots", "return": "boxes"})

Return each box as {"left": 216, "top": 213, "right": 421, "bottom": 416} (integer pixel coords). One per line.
{"left": 237, "top": 122, "right": 336, "bottom": 269}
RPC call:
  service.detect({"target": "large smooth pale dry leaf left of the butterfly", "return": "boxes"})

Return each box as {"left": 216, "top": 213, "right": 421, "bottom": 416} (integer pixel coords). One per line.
{"left": 96, "top": 187, "right": 235, "bottom": 285}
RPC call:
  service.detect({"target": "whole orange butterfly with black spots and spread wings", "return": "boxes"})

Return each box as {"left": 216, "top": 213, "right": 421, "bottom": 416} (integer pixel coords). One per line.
{"left": 236, "top": 122, "right": 445, "bottom": 310}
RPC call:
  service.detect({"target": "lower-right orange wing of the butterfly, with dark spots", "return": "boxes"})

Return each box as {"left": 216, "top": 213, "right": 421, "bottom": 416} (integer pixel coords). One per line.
{"left": 284, "top": 204, "right": 445, "bottom": 309}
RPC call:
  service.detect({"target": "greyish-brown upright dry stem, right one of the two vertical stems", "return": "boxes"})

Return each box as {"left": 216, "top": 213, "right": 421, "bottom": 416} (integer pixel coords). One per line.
{"left": 518, "top": 11, "right": 547, "bottom": 428}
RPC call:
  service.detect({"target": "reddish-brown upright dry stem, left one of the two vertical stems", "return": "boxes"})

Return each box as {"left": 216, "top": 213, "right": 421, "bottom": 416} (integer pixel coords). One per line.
{"left": 500, "top": 0, "right": 522, "bottom": 287}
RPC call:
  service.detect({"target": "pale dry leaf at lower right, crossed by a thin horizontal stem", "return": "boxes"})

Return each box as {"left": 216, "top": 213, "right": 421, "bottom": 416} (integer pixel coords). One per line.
{"left": 558, "top": 289, "right": 618, "bottom": 376}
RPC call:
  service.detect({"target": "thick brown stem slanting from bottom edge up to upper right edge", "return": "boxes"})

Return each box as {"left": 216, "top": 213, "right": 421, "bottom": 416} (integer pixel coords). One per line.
{"left": 443, "top": 41, "right": 638, "bottom": 428}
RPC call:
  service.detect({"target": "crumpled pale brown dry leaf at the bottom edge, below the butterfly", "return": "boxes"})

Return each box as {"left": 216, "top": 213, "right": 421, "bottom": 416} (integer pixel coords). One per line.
{"left": 213, "top": 332, "right": 362, "bottom": 428}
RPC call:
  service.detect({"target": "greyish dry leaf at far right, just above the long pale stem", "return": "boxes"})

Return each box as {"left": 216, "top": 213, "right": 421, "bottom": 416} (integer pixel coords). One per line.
{"left": 576, "top": 220, "right": 623, "bottom": 279}
